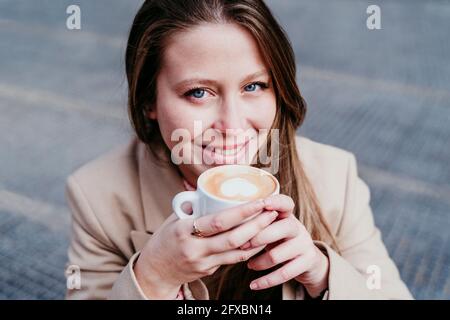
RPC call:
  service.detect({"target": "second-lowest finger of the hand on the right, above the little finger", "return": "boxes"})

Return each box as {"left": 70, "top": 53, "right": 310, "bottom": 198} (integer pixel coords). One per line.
{"left": 247, "top": 239, "right": 302, "bottom": 271}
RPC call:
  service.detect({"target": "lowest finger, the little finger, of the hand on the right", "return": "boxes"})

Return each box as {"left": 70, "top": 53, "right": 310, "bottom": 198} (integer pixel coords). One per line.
{"left": 250, "top": 257, "right": 306, "bottom": 290}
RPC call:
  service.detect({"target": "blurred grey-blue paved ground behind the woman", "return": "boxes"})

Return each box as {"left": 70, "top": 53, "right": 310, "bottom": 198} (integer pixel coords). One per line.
{"left": 0, "top": 0, "right": 450, "bottom": 299}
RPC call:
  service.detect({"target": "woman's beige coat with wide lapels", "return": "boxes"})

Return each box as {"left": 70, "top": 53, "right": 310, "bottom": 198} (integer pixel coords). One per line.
{"left": 66, "top": 137, "right": 411, "bottom": 299}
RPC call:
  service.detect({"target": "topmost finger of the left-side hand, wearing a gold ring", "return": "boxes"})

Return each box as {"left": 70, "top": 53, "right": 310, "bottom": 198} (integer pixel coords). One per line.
{"left": 195, "top": 200, "right": 264, "bottom": 236}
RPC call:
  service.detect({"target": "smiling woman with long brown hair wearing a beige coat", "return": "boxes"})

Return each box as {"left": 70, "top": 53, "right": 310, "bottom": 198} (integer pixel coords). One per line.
{"left": 63, "top": 0, "right": 410, "bottom": 299}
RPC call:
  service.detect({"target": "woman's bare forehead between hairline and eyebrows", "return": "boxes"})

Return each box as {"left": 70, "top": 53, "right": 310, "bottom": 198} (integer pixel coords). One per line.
{"left": 161, "top": 23, "right": 265, "bottom": 78}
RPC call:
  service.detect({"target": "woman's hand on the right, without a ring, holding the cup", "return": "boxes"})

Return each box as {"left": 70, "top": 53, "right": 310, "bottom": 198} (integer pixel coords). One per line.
{"left": 241, "top": 195, "right": 329, "bottom": 297}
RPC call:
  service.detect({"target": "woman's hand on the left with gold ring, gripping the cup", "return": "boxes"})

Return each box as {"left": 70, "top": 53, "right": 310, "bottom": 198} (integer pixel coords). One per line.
{"left": 134, "top": 200, "right": 278, "bottom": 299}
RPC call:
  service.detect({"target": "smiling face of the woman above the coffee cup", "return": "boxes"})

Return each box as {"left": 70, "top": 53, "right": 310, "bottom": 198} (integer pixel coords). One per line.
{"left": 149, "top": 24, "right": 276, "bottom": 183}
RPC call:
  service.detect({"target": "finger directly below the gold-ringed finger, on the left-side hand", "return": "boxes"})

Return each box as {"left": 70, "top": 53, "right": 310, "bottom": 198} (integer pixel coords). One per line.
{"left": 208, "top": 211, "right": 278, "bottom": 253}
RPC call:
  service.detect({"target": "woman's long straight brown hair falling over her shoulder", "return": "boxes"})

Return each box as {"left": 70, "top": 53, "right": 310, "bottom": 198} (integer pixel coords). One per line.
{"left": 126, "top": 0, "right": 337, "bottom": 299}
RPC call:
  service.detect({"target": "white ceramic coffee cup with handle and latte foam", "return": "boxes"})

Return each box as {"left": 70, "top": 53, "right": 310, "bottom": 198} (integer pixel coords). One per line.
{"left": 172, "top": 165, "right": 280, "bottom": 219}
